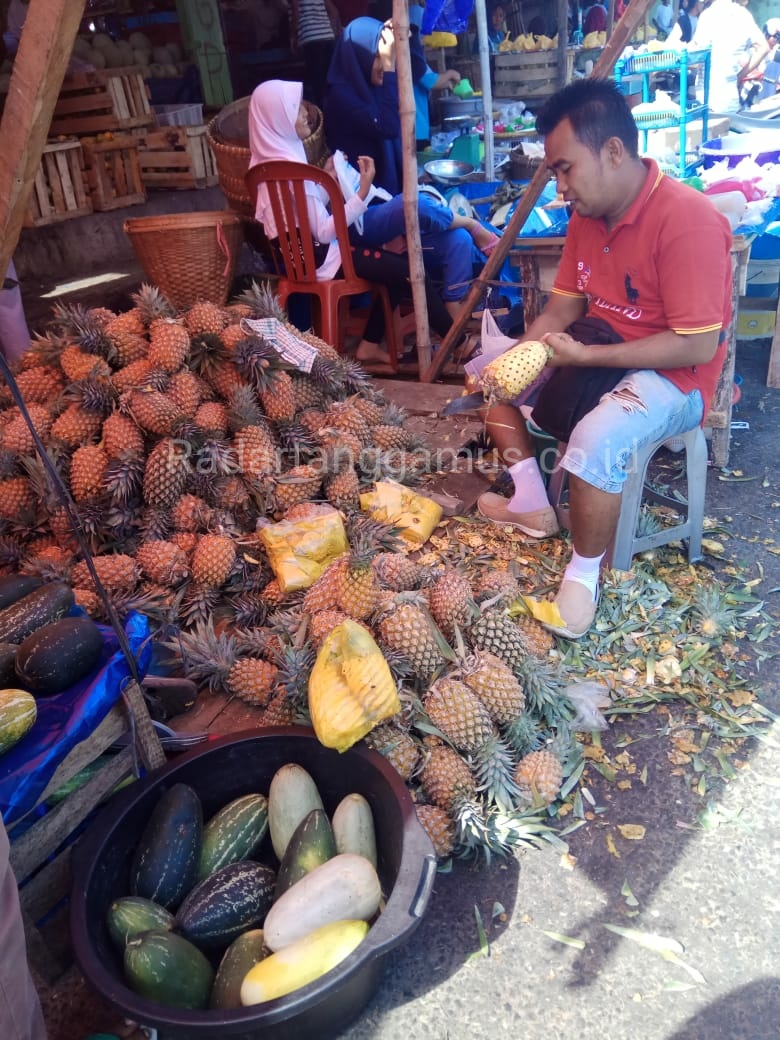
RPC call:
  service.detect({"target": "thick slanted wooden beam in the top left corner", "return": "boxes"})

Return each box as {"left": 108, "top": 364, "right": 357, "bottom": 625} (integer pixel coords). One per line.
{"left": 0, "top": 0, "right": 85, "bottom": 276}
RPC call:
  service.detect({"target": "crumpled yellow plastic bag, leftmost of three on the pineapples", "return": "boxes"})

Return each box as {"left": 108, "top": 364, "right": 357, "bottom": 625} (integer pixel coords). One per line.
{"left": 260, "top": 511, "right": 349, "bottom": 593}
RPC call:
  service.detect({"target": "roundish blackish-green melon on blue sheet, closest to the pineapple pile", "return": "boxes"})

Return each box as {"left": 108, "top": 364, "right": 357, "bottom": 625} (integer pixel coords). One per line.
{"left": 16, "top": 618, "right": 103, "bottom": 696}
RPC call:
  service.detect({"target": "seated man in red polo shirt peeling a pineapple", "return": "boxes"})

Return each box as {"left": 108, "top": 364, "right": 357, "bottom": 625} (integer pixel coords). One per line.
{"left": 478, "top": 79, "right": 731, "bottom": 639}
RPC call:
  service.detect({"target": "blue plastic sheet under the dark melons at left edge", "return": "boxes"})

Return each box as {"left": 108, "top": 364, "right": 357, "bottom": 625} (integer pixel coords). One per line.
{"left": 0, "top": 614, "right": 152, "bottom": 827}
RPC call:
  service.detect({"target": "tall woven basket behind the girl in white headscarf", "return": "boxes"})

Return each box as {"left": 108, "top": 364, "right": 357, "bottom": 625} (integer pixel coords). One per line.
{"left": 206, "top": 98, "right": 330, "bottom": 217}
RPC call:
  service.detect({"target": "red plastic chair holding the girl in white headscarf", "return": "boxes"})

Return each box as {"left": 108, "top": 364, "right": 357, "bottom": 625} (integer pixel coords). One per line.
{"left": 245, "top": 160, "right": 399, "bottom": 367}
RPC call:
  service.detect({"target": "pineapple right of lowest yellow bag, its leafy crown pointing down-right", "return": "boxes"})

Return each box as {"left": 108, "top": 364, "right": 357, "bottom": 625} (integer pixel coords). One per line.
{"left": 423, "top": 678, "right": 517, "bottom": 809}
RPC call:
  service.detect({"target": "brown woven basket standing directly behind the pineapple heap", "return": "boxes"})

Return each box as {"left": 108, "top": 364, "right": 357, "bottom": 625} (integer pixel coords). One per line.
{"left": 125, "top": 209, "right": 243, "bottom": 310}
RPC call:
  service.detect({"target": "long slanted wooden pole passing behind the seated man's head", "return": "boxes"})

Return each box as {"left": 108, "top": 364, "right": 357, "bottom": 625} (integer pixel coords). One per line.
{"left": 420, "top": 0, "right": 655, "bottom": 383}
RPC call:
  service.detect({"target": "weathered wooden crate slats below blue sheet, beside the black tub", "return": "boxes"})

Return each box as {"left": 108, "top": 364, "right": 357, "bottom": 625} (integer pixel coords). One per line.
{"left": 9, "top": 682, "right": 165, "bottom": 985}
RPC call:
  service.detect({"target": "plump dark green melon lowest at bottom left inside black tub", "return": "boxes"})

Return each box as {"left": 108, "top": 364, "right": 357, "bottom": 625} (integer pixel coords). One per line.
{"left": 125, "top": 929, "right": 214, "bottom": 1011}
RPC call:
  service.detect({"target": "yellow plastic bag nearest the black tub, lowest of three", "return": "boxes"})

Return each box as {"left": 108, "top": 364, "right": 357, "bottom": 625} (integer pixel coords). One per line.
{"left": 309, "top": 621, "right": 400, "bottom": 751}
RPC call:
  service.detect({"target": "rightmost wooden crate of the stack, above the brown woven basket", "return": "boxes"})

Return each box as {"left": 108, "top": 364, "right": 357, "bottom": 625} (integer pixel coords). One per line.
{"left": 138, "top": 125, "right": 218, "bottom": 188}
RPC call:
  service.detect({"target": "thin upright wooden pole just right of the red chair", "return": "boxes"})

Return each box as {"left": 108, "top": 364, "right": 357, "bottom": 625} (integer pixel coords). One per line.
{"left": 393, "top": 0, "right": 431, "bottom": 371}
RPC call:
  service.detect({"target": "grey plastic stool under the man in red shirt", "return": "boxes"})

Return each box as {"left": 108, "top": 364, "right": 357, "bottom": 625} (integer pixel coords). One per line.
{"left": 548, "top": 426, "right": 707, "bottom": 571}
